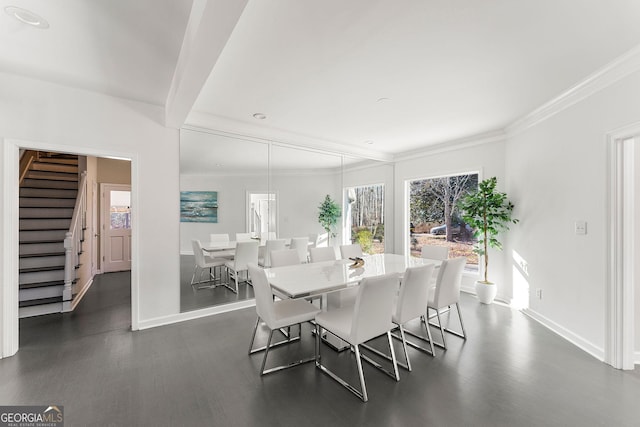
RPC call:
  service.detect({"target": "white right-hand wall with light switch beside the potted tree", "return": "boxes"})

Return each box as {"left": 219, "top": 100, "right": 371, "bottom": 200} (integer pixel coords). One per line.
{"left": 506, "top": 72, "right": 640, "bottom": 358}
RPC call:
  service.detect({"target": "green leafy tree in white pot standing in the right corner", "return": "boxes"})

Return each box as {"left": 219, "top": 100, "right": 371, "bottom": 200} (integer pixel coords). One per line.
{"left": 458, "top": 177, "right": 518, "bottom": 304}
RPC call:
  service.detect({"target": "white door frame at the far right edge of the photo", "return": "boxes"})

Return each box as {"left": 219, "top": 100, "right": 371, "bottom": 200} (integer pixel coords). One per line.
{"left": 604, "top": 123, "right": 640, "bottom": 369}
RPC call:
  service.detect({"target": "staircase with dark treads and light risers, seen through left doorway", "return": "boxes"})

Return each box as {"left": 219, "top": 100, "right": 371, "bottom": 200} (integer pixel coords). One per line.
{"left": 19, "top": 152, "right": 78, "bottom": 318}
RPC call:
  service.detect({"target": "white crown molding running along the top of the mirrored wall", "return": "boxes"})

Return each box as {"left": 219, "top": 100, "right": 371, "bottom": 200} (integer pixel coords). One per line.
{"left": 183, "top": 111, "right": 393, "bottom": 162}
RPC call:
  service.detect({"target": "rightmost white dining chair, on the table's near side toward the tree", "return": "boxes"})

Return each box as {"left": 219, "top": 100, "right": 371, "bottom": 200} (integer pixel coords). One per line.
{"left": 427, "top": 257, "right": 467, "bottom": 350}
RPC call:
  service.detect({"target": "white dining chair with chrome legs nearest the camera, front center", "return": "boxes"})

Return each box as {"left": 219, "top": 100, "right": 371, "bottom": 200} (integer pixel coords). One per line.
{"left": 315, "top": 273, "right": 400, "bottom": 402}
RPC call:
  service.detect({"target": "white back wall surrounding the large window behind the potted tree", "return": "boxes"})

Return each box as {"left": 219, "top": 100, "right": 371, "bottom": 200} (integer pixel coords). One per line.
{"left": 393, "top": 137, "right": 508, "bottom": 294}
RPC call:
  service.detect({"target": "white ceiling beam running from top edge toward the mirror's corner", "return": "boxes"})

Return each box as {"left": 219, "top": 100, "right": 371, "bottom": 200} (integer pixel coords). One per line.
{"left": 165, "top": 0, "right": 248, "bottom": 128}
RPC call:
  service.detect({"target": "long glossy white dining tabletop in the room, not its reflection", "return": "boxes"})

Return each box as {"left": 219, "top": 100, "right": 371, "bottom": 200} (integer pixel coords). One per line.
{"left": 265, "top": 254, "right": 442, "bottom": 298}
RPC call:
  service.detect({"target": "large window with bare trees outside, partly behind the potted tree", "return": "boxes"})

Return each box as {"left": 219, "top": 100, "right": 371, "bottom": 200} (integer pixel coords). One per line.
{"left": 408, "top": 173, "right": 478, "bottom": 271}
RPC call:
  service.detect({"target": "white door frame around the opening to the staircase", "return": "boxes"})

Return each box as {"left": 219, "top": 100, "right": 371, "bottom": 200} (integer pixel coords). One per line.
{"left": 0, "top": 138, "right": 140, "bottom": 358}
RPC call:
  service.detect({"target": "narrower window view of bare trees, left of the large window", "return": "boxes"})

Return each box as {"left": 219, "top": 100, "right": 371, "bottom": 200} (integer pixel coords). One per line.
{"left": 344, "top": 184, "right": 384, "bottom": 254}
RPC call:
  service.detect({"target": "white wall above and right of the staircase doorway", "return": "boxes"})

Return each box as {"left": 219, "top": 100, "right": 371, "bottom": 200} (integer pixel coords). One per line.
{"left": 0, "top": 74, "right": 180, "bottom": 352}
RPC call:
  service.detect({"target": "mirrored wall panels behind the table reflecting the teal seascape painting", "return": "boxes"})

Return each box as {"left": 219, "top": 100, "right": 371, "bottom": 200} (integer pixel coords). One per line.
{"left": 180, "top": 129, "right": 357, "bottom": 312}
